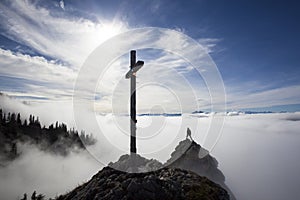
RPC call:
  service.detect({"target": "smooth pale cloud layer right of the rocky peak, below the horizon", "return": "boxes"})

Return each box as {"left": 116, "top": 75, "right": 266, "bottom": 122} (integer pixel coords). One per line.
{"left": 212, "top": 113, "right": 300, "bottom": 200}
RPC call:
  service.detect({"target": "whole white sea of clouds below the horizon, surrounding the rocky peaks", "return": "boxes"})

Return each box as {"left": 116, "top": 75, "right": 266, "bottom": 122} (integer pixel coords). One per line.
{"left": 0, "top": 95, "right": 300, "bottom": 200}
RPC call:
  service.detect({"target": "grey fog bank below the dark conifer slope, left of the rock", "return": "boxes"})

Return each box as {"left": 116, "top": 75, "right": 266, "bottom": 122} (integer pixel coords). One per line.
{"left": 0, "top": 145, "right": 103, "bottom": 200}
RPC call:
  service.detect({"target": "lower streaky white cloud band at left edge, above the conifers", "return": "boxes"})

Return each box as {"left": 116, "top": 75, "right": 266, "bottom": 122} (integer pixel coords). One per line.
{"left": 0, "top": 49, "right": 76, "bottom": 99}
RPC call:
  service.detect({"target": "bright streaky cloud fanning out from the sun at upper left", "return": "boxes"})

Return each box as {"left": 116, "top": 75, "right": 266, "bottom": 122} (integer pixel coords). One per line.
{"left": 0, "top": 0, "right": 127, "bottom": 68}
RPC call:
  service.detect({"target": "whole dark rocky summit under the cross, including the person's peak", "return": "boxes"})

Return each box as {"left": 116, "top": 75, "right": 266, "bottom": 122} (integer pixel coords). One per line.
{"left": 57, "top": 139, "right": 235, "bottom": 200}
